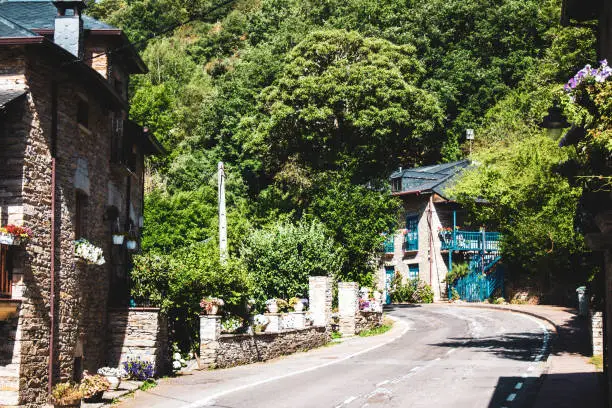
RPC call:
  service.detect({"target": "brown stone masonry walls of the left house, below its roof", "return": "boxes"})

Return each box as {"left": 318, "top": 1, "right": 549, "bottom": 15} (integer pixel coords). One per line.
{"left": 0, "top": 3, "right": 161, "bottom": 407}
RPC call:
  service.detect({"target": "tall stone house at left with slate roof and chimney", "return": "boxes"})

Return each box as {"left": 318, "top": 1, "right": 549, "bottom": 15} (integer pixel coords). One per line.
{"left": 0, "top": 0, "right": 162, "bottom": 406}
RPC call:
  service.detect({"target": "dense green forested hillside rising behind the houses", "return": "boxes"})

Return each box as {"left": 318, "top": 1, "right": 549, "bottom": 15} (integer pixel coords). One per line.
{"left": 88, "top": 0, "right": 595, "bottom": 338}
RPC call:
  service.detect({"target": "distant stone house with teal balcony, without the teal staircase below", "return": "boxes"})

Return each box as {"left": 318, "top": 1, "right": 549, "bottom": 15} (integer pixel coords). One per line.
{"left": 377, "top": 160, "right": 499, "bottom": 302}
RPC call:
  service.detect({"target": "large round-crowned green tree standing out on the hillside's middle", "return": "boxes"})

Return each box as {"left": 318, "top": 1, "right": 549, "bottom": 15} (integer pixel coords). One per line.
{"left": 250, "top": 30, "right": 441, "bottom": 181}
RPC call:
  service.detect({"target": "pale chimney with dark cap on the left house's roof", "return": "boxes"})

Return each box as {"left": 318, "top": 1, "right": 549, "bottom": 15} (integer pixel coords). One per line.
{"left": 53, "top": 0, "right": 85, "bottom": 59}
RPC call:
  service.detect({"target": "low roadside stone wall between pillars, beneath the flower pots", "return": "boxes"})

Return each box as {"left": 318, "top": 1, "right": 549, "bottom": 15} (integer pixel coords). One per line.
{"left": 214, "top": 327, "right": 329, "bottom": 368}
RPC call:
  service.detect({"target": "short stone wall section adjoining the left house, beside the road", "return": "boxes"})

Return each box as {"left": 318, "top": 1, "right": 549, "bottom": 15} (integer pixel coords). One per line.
{"left": 107, "top": 308, "right": 170, "bottom": 375}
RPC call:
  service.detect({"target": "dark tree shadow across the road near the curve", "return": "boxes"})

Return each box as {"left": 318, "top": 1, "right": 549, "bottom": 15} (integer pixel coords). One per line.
{"left": 432, "top": 332, "right": 542, "bottom": 361}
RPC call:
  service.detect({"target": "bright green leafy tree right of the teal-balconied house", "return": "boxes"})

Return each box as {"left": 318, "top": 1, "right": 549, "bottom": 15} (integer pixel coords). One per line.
{"left": 453, "top": 134, "right": 590, "bottom": 301}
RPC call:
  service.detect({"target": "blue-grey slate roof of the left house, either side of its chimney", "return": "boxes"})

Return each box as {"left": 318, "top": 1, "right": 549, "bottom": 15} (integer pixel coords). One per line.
{"left": 0, "top": 0, "right": 116, "bottom": 30}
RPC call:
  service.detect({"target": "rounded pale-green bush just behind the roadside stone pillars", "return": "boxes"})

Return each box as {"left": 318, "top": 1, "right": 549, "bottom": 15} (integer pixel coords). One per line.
{"left": 240, "top": 222, "right": 343, "bottom": 310}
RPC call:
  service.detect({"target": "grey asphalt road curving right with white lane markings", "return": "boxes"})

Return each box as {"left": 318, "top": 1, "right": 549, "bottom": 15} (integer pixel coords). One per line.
{"left": 121, "top": 305, "right": 550, "bottom": 408}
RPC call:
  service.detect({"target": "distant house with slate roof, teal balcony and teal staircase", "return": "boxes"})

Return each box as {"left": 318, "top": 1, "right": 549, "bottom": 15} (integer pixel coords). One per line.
{"left": 377, "top": 160, "right": 503, "bottom": 301}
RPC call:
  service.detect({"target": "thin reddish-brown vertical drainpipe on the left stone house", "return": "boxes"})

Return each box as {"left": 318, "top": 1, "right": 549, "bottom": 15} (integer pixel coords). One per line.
{"left": 48, "top": 81, "right": 57, "bottom": 394}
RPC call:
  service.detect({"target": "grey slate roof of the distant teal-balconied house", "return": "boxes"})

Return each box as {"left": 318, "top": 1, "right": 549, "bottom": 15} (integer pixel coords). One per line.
{"left": 389, "top": 160, "right": 470, "bottom": 197}
